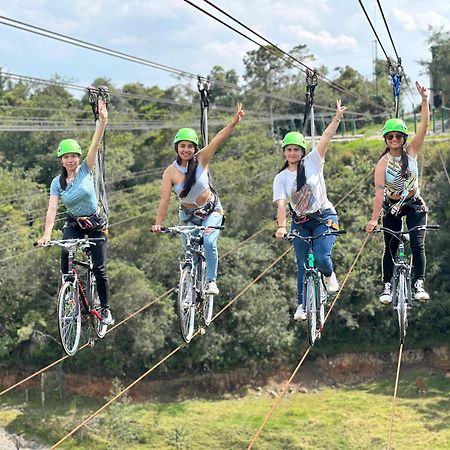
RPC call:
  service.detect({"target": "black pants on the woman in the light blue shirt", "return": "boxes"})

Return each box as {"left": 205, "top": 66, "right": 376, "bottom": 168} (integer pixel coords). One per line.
{"left": 61, "top": 224, "right": 109, "bottom": 308}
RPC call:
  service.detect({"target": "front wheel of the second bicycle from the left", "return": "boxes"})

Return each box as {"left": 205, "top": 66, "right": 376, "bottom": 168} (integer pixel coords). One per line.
{"left": 178, "top": 267, "right": 196, "bottom": 343}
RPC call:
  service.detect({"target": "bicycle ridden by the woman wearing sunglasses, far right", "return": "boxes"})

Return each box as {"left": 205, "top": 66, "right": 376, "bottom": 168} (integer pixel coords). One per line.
{"left": 373, "top": 225, "right": 439, "bottom": 344}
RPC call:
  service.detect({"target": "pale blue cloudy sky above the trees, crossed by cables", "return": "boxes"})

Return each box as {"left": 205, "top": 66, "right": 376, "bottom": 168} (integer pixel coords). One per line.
{"left": 0, "top": 0, "right": 450, "bottom": 107}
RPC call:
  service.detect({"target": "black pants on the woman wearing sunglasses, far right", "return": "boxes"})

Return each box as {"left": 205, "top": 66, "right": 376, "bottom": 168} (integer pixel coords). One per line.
{"left": 383, "top": 199, "right": 427, "bottom": 283}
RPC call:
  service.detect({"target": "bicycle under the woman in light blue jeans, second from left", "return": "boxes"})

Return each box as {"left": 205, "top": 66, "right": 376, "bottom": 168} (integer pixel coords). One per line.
{"left": 161, "top": 225, "right": 224, "bottom": 343}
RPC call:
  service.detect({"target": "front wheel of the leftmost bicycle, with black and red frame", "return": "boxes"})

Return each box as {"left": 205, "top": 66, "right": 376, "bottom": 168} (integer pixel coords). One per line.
{"left": 58, "top": 281, "right": 81, "bottom": 356}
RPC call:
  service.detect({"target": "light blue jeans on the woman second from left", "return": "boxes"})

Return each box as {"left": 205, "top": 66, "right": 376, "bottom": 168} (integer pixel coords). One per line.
{"left": 178, "top": 202, "right": 223, "bottom": 281}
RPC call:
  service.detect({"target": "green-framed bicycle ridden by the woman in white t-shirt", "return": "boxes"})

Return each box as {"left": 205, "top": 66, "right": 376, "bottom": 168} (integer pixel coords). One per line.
{"left": 284, "top": 229, "right": 347, "bottom": 346}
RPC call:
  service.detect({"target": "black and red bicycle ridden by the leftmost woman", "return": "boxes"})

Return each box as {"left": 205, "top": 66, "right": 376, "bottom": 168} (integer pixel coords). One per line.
{"left": 40, "top": 238, "right": 112, "bottom": 356}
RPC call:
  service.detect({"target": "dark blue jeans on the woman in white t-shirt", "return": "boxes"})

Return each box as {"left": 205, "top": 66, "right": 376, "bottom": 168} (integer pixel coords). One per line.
{"left": 292, "top": 209, "right": 338, "bottom": 305}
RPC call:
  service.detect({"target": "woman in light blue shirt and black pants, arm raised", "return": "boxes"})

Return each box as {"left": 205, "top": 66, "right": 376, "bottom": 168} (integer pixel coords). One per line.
{"left": 38, "top": 99, "right": 113, "bottom": 325}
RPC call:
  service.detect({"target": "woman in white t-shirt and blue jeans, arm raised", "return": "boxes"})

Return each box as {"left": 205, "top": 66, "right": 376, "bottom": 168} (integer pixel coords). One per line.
{"left": 273, "top": 100, "right": 347, "bottom": 320}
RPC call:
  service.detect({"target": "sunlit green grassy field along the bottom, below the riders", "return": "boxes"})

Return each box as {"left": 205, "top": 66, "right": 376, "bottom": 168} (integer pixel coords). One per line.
{"left": 0, "top": 376, "right": 450, "bottom": 450}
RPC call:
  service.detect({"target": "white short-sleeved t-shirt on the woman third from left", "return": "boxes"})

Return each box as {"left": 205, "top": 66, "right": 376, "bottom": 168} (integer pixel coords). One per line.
{"left": 273, "top": 147, "right": 335, "bottom": 214}
